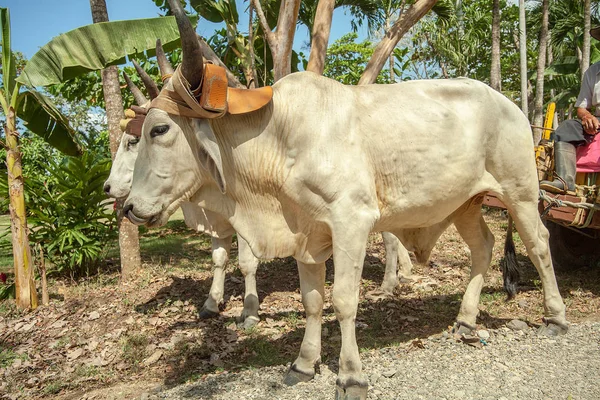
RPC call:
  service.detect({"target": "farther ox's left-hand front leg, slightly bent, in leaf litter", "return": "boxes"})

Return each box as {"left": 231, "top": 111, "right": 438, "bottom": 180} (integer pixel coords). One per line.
{"left": 200, "top": 236, "right": 232, "bottom": 319}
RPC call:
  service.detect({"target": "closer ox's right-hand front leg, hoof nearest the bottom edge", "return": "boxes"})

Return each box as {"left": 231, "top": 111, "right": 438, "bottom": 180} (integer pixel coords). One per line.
{"left": 332, "top": 230, "right": 368, "bottom": 400}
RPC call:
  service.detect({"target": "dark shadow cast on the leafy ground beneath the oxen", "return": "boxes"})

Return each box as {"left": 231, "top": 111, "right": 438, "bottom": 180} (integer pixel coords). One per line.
{"left": 136, "top": 253, "right": 508, "bottom": 386}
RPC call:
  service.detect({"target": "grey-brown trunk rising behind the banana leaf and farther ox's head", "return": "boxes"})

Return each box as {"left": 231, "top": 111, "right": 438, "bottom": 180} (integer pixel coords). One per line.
{"left": 90, "top": 0, "right": 141, "bottom": 281}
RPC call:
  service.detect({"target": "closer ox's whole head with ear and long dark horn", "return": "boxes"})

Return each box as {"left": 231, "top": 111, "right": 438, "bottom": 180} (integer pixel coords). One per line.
{"left": 123, "top": 0, "right": 225, "bottom": 226}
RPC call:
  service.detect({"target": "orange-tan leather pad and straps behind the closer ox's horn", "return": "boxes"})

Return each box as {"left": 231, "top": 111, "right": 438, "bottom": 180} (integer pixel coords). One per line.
{"left": 150, "top": 64, "right": 273, "bottom": 119}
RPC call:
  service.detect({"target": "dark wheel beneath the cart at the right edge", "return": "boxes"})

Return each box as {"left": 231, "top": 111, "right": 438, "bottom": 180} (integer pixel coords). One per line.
{"left": 546, "top": 221, "right": 600, "bottom": 270}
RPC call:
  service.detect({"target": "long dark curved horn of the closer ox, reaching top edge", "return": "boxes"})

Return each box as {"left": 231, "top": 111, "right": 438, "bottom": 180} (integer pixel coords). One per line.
{"left": 168, "top": 0, "right": 204, "bottom": 90}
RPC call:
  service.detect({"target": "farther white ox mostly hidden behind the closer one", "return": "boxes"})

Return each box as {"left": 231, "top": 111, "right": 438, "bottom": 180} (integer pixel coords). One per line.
{"left": 104, "top": 65, "right": 418, "bottom": 328}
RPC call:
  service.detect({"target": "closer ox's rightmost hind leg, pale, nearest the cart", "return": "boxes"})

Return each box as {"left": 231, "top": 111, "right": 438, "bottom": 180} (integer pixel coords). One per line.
{"left": 502, "top": 200, "right": 568, "bottom": 336}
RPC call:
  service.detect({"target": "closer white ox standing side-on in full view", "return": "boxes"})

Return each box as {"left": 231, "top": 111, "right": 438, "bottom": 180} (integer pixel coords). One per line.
{"left": 124, "top": 0, "right": 567, "bottom": 399}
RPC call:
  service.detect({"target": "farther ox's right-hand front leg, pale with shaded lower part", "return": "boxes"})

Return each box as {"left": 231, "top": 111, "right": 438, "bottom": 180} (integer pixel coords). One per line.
{"left": 238, "top": 235, "right": 260, "bottom": 329}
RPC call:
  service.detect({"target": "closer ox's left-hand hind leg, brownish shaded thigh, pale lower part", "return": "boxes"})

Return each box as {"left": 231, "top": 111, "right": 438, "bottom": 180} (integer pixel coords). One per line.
{"left": 454, "top": 202, "right": 494, "bottom": 330}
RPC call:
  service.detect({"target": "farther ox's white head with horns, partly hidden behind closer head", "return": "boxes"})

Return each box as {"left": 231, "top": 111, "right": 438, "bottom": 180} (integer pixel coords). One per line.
{"left": 104, "top": 46, "right": 173, "bottom": 199}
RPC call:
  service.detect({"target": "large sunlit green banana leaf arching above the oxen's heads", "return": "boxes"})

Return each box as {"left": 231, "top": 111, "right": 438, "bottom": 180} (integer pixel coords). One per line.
{"left": 17, "top": 17, "right": 196, "bottom": 87}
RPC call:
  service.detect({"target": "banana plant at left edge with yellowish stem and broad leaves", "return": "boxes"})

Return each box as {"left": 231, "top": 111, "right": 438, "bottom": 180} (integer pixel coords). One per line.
{"left": 0, "top": 8, "right": 185, "bottom": 308}
